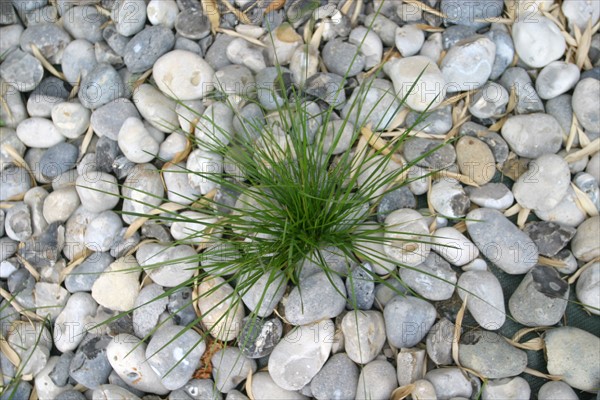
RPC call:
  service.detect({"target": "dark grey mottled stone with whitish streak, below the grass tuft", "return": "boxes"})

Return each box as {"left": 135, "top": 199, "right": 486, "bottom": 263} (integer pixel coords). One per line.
{"left": 238, "top": 316, "right": 283, "bottom": 358}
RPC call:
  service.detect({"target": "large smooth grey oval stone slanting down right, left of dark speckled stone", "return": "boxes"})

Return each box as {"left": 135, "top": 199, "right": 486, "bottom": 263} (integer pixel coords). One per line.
{"left": 466, "top": 208, "right": 539, "bottom": 276}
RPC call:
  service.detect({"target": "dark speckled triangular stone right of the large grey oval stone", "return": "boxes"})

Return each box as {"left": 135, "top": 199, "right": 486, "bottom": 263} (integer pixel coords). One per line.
{"left": 523, "top": 221, "right": 576, "bottom": 257}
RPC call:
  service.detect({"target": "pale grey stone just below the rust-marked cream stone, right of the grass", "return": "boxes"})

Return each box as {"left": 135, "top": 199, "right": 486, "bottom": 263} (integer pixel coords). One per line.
{"left": 400, "top": 253, "right": 458, "bottom": 301}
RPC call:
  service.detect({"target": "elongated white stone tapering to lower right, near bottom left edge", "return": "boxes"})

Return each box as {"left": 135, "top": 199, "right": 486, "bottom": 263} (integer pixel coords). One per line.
{"left": 106, "top": 332, "right": 169, "bottom": 395}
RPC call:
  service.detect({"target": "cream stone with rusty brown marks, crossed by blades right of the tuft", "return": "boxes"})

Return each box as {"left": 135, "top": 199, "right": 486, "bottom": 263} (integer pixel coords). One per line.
{"left": 383, "top": 208, "right": 431, "bottom": 267}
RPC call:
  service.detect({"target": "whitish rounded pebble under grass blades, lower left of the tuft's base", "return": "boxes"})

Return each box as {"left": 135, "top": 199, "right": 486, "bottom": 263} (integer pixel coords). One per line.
{"left": 136, "top": 243, "right": 198, "bottom": 287}
